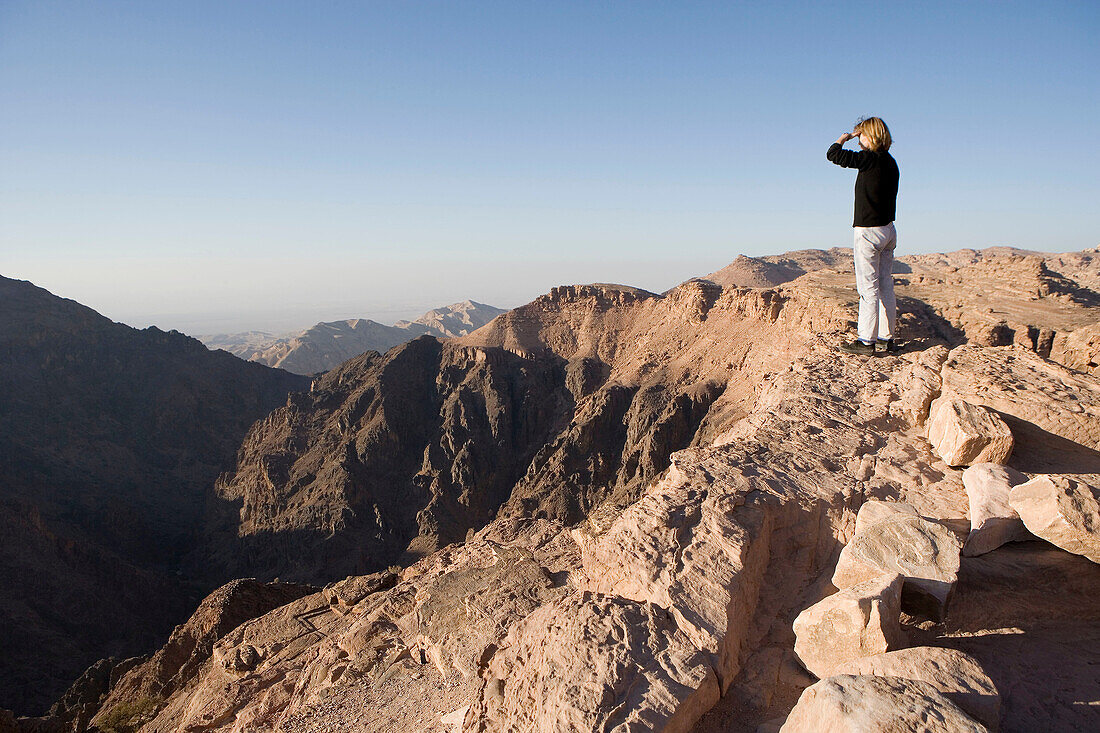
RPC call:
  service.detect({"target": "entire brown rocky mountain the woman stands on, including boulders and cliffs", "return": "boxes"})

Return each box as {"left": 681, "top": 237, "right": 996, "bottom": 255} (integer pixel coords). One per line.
{"left": 8, "top": 250, "right": 1100, "bottom": 733}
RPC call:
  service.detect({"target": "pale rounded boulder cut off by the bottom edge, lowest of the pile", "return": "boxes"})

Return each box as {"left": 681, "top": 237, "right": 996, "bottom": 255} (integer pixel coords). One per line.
{"left": 780, "top": 675, "right": 988, "bottom": 733}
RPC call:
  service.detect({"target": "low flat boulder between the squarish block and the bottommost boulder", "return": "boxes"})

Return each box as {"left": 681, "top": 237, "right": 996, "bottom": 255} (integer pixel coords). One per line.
{"left": 834, "top": 646, "right": 1001, "bottom": 731}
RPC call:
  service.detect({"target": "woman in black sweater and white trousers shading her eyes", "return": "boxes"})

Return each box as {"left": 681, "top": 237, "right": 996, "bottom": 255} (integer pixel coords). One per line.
{"left": 825, "top": 117, "right": 898, "bottom": 355}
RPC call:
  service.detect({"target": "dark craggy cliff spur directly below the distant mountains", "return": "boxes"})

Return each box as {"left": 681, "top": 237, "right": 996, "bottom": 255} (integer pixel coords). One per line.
{"left": 193, "top": 337, "right": 572, "bottom": 584}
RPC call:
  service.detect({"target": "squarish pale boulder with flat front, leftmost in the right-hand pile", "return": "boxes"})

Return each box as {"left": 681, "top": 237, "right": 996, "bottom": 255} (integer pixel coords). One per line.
{"left": 794, "top": 573, "right": 905, "bottom": 679}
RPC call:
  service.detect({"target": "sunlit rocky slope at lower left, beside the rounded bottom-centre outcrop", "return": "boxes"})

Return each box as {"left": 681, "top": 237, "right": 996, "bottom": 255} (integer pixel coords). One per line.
{"left": 144, "top": 519, "right": 578, "bottom": 733}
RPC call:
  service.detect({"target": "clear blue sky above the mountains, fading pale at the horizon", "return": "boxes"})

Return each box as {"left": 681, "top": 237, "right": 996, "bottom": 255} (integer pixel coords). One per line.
{"left": 0, "top": 0, "right": 1100, "bottom": 332}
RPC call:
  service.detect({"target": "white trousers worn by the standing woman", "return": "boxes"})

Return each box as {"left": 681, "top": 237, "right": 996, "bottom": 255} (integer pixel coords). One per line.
{"left": 853, "top": 222, "right": 898, "bottom": 343}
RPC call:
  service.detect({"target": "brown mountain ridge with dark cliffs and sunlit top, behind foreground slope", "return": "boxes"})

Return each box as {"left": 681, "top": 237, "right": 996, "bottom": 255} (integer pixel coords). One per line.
{"left": 193, "top": 281, "right": 842, "bottom": 583}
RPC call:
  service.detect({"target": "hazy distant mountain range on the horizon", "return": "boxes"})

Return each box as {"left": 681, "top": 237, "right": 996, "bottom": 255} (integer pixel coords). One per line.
{"left": 197, "top": 300, "right": 505, "bottom": 374}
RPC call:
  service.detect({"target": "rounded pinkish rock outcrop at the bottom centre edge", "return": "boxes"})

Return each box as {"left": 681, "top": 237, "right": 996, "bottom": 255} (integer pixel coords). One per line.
{"left": 463, "top": 591, "right": 719, "bottom": 733}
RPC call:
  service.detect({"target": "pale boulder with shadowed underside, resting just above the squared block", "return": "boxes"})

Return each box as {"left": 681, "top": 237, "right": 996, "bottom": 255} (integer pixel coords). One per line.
{"left": 833, "top": 502, "right": 961, "bottom": 619}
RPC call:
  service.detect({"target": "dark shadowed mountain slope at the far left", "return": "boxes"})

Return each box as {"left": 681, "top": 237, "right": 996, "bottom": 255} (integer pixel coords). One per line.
{"left": 0, "top": 277, "right": 309, "bottom": 712}
